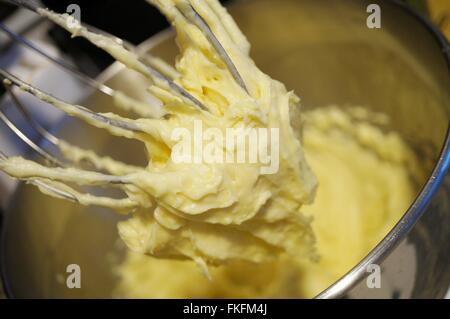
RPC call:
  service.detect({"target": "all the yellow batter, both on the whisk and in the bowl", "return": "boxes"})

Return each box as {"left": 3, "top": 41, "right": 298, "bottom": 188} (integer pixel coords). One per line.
{"left": 0, "top": 0, "right": 422, "bottom": 298}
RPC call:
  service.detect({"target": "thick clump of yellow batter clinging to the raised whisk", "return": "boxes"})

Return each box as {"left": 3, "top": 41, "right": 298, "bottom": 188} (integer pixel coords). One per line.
{"left": 0, "top": 0, "right": 317, "bottom": 275}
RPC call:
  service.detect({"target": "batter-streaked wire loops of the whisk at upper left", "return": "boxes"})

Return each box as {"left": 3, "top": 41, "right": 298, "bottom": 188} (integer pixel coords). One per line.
{"left": 0, "top": 0, "right": 248, "bottom": 208}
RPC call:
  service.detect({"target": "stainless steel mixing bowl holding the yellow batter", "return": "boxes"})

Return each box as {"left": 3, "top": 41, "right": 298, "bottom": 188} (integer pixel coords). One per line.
{"left": 1, "top": 0, "right": 450, "bottom": 298}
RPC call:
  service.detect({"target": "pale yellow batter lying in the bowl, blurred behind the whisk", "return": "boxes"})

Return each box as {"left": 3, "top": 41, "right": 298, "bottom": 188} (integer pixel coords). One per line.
{"left": 117, "top": 107, "right": 418, "bottom": 298}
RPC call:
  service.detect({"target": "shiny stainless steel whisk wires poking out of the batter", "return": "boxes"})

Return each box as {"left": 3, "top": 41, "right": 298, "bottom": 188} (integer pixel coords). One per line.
{"left": 0, "top": 0, "right": 248, "bottom": 208}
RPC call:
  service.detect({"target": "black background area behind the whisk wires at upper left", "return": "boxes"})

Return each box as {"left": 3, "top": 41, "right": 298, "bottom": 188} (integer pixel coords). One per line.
{"left": 0, "top": 0, "right": 229, "bottom": 77}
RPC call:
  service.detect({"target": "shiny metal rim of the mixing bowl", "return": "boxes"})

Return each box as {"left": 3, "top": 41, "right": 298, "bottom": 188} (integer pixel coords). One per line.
{"left": 0, "top": 0, "right": 450, "bottom": 299}
